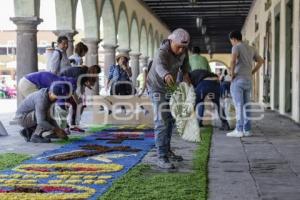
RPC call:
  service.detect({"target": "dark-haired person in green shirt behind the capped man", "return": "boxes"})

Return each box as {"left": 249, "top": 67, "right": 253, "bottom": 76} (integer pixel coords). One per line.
{"left": 189, "top": 47, "right": 211, "bottom": 72}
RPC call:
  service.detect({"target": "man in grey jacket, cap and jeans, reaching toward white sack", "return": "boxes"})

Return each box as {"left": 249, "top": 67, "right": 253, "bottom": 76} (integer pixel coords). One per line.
{"left": 147, "top": 28, "right": 190, "bottom": 169}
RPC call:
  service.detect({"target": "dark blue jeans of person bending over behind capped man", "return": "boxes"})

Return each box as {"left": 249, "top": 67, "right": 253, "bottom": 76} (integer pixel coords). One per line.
{"left": 195, "top": 80, "right": 227, "bottom": 125}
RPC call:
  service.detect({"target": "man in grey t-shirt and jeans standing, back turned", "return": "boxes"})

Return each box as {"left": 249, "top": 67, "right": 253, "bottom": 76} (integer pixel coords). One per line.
{"left": 227, "top": 31, "right": 264, "bottom": 137}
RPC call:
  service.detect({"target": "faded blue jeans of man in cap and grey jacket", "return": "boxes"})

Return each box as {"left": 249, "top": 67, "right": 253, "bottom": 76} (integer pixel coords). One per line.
{"left": 150, "top": 92, "right": 175, "bottom": 157}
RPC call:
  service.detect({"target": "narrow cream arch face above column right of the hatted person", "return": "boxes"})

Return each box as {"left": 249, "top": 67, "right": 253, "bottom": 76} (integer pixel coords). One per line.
{"left": 130, "top": 12, "right": 140, "bottom": 53}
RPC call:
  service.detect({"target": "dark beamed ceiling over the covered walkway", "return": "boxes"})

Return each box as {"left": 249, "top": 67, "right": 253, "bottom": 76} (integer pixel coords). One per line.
{"left": 143, "top": 0, "right": 253, "bottom": 53}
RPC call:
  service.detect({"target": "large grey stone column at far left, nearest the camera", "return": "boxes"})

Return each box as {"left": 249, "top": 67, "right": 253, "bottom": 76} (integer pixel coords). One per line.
{"left": 10, "top": 17, "right": 43, "bottom": 104}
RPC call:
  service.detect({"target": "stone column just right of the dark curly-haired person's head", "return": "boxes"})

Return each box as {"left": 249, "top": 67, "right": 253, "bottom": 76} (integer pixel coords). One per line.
{"left": 82, "top": 38, "right": 100, "bottom": 95}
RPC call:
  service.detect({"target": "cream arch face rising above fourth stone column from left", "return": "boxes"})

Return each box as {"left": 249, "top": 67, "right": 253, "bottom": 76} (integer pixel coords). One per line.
{"left": 99, "top": 0, "right": 117, "bottom": 45}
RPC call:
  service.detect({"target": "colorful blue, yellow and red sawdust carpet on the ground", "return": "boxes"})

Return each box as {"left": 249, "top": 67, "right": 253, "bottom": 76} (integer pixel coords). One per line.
{"left": 0, "top": 126, "right": 154, "bottom": 200}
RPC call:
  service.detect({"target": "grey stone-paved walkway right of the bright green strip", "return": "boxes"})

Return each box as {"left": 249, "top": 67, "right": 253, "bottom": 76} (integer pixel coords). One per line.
{"left": 209, "top": 111, "right": 300, "bottom": 200}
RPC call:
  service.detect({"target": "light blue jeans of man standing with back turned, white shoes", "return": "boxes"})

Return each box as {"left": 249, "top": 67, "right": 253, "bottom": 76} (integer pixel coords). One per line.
{"left": 230, "top": 79, "right": 252, "bottom": 131}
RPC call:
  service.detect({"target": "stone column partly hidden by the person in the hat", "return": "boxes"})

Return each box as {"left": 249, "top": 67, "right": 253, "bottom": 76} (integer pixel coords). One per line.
{"left": 102, "top": 44, "right": 118, "bottom": 78}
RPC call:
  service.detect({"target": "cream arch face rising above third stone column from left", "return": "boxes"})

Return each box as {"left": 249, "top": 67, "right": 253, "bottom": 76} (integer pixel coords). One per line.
{"left": 79, "top": 0, "right": 99, "bottom": 39}
